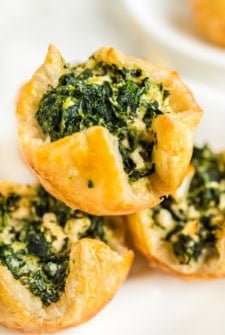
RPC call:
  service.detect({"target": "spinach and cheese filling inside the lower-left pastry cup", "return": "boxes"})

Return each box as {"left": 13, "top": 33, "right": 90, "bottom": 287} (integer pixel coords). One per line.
{"left": 0, "top": 186, "right": 108, "bottom": 306}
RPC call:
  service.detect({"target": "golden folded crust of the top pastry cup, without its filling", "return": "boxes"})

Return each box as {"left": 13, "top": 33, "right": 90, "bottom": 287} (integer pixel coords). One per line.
{"left": 16, "top": 45, "right": 202, "bottom": 215}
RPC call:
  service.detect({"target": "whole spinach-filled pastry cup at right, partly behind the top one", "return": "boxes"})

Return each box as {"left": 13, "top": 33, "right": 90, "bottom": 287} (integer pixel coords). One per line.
{"left": 127, "top": 146, "right": 225, "bottom": 278}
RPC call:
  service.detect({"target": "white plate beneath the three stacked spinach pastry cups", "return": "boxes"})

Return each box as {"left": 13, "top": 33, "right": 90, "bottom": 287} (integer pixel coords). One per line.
{"left": 0, "top": 76, "right": 225, "bottom": 335}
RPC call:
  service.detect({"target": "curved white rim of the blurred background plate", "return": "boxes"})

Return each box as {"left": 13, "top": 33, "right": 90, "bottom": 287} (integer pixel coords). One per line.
{"left": 122, "top": 0, "right": 225, "bottom": 70}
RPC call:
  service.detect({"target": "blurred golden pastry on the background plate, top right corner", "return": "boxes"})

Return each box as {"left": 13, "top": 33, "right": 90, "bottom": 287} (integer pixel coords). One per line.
{"left": 190, "top": 0, "right": 225, "bottom": 46}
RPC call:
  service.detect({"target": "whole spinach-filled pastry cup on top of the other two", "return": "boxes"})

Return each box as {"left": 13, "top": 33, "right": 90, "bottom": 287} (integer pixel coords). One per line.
{"left": 17, "top": 45, "right": 202, "bottom": 215}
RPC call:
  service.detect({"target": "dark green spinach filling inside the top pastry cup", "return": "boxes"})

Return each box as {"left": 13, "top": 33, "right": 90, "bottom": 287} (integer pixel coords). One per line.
{"left": 35, "top": 56, "right": 169, "bottom": 182}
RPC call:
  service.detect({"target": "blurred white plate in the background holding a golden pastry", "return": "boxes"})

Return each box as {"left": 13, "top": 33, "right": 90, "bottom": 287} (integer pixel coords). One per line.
{"left": 122, "top": 0, "right": 225, "bottom": 90}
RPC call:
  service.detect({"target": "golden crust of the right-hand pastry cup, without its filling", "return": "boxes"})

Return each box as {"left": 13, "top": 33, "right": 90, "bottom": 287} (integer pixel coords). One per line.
{"left": 126, "top": 166, "right": 225, "bottom": 279}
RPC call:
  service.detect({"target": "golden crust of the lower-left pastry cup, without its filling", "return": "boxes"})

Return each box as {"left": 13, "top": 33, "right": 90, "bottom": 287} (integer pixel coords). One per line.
{"left": 0, "top": 182, "right": 133, "bottom": 334}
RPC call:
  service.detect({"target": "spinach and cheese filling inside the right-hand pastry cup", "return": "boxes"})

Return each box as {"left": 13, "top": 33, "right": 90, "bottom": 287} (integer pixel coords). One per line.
{"left": 152, "top": 145, "right": 225, "bottom": 265}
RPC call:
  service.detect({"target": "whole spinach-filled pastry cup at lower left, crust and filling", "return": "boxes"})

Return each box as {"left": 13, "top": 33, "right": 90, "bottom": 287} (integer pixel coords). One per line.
{"left": 0, "top": 182, "right": 133, "bottom": 335}
